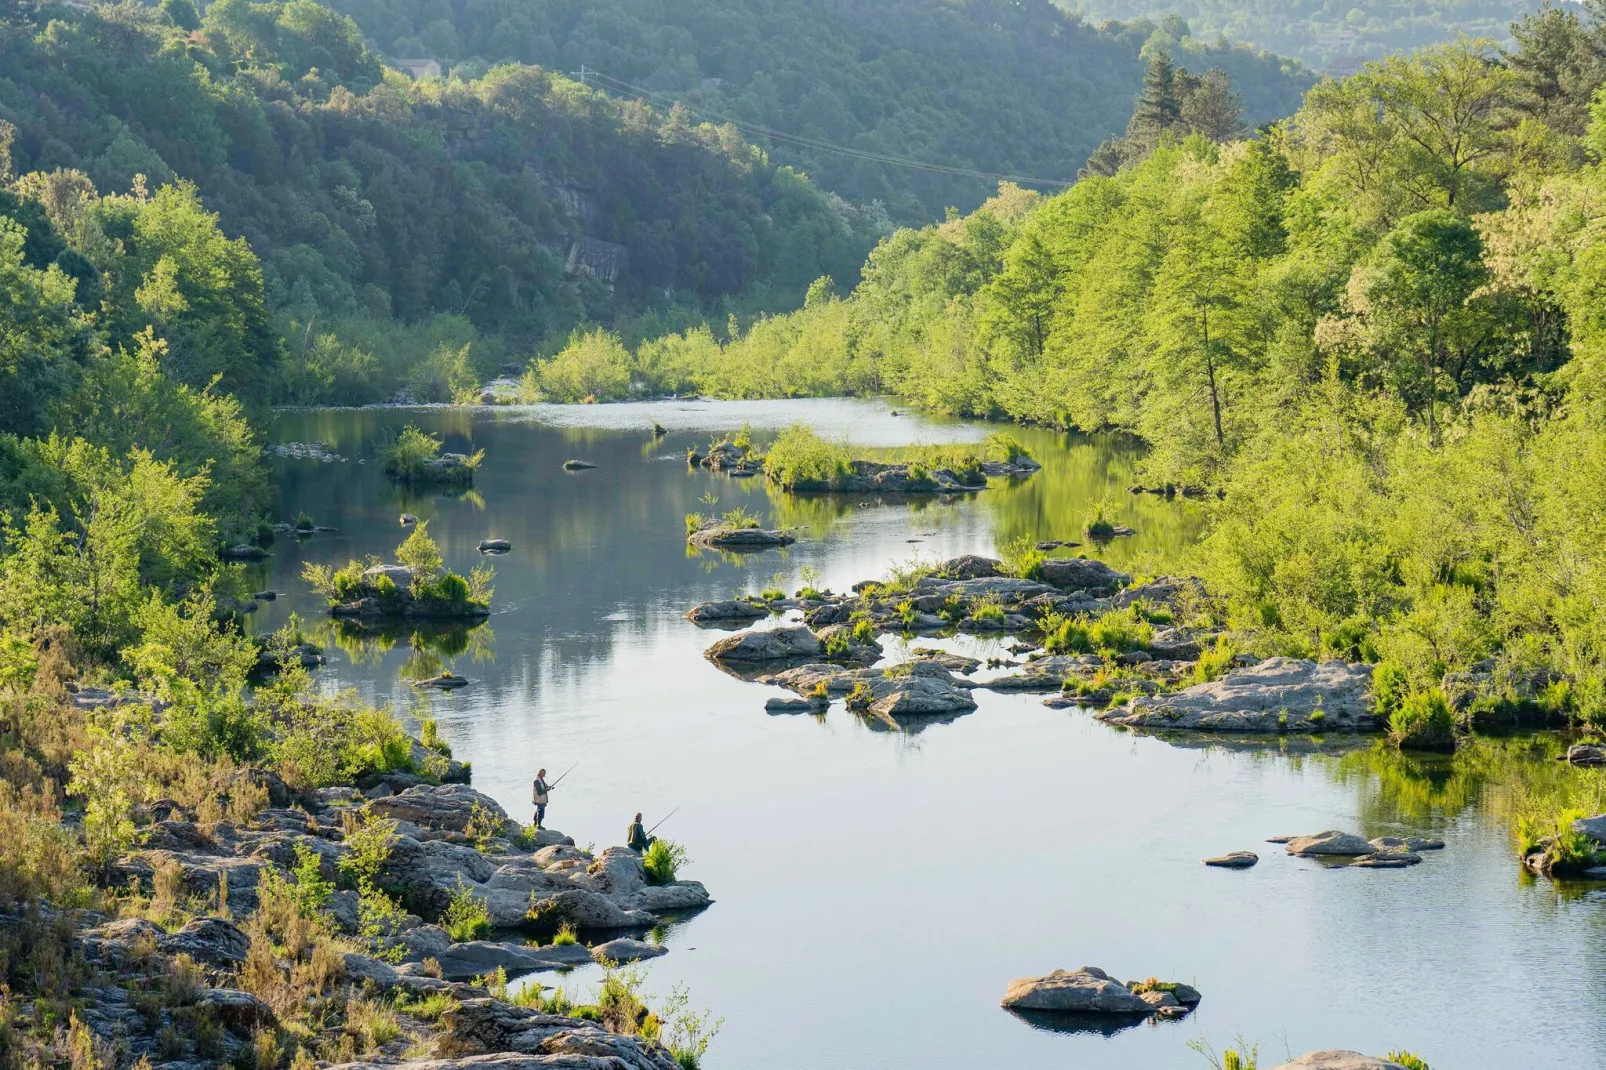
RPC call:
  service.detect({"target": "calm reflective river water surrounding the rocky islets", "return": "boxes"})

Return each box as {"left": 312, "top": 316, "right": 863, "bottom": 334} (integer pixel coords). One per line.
{"left": 259, "top": 400, "right": 1606, "bottom": 1070}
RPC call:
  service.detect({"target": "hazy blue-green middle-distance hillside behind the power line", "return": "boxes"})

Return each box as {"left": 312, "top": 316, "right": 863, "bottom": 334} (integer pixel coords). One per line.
{"left": 319, "top": 0, "right": 1310, "bottom": 223}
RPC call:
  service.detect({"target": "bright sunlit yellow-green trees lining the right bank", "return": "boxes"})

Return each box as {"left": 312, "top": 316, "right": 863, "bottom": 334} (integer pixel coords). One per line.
{"left": 542, "top": 8, "right": 1606, "bottom": 723}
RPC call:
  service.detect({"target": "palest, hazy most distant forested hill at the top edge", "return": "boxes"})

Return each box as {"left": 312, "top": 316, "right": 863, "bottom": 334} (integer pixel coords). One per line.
{"left": 1058, "top": 0, "right": 1537, "bottom": 69}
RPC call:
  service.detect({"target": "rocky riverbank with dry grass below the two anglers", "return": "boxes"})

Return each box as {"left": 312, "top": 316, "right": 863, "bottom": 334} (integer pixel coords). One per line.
{"left": 12, "top": 741, "right": 710, "bottom": 1070}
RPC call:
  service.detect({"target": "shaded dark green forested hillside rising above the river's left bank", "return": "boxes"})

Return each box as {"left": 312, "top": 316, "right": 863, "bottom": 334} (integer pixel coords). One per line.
{"left": 0, "top": 0, "right": 885, "bottom": 402}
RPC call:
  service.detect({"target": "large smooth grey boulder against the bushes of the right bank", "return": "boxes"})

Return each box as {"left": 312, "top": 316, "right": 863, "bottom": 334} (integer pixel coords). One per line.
{"left": 1097, "top": 657, "right": 1378, "bottom": 733}
